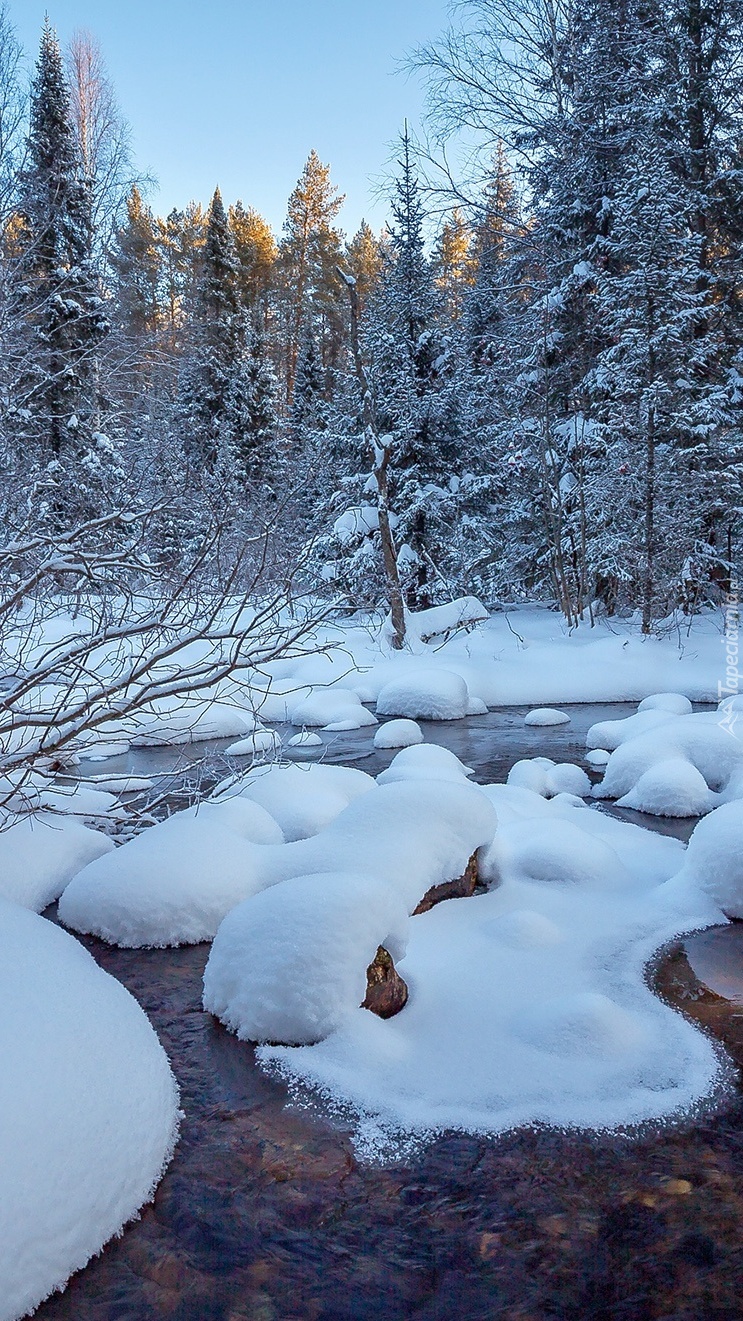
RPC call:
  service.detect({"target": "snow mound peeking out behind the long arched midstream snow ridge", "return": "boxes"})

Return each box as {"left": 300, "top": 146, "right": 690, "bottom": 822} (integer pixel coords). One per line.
{"left": 224, "top": 762, "right": 374, "bottom": 841}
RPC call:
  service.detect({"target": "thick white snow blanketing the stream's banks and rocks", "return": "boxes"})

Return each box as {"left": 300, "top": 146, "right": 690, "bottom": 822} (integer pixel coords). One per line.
{"left": 0, "top": 601, "right": 743, "bottom": 1321}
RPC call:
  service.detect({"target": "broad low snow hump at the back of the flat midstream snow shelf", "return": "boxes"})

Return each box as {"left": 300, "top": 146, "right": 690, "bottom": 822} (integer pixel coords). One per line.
{"left": 480, "top": 816, "right": 629, "bottom": 888}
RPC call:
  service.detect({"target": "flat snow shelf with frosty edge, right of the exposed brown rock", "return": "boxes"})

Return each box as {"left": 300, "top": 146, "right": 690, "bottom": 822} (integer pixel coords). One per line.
{"left": 253, "top": 785, "right": 724, "bottom": 1156}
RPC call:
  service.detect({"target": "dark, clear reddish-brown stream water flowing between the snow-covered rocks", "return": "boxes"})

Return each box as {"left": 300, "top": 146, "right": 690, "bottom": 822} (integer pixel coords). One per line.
{"left": 36, "top": 705, "right": 743, "bottom": 1321}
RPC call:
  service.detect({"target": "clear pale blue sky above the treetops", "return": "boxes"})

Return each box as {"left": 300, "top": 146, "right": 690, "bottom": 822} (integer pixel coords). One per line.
{"left": 11, "top": 0, "right": 447, "bottom": 232}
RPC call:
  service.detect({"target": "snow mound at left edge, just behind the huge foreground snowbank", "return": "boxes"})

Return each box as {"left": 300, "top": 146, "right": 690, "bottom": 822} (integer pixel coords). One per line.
{"left": 0, "top": 812, "right": 114, "bottom": 913}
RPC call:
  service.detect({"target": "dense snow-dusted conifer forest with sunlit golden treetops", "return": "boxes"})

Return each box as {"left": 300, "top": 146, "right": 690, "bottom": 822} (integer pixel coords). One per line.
{"left": 0, "top": 0, "right": 743, "bottom": 629}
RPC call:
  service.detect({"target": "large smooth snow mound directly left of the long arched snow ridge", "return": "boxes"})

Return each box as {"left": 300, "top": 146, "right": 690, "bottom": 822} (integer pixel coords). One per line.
{"left": 58, "top": 808, "right": 264, "bottom": 948}
